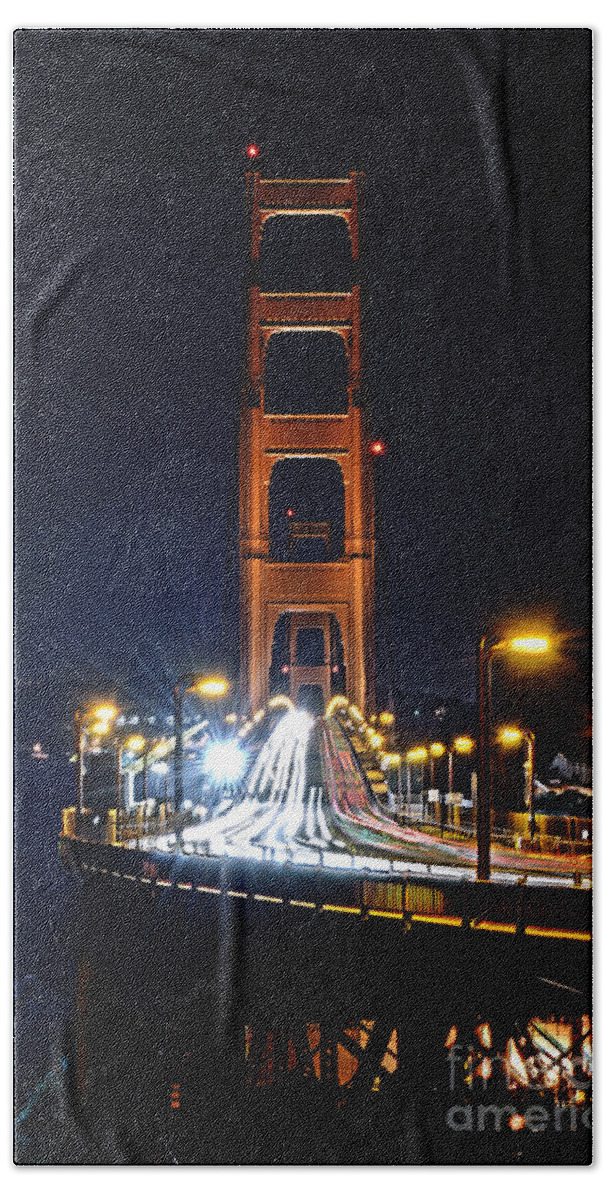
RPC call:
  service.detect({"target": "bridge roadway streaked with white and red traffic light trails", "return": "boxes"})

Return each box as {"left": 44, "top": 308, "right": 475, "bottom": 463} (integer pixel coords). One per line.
{"left": 140, "top": 710, "right": 590, "bottom": 887}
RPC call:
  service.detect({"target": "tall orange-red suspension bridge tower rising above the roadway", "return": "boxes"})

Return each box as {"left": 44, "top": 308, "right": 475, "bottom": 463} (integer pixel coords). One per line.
{"left": 239, "top": 172, "right": 374, "bottom": 709}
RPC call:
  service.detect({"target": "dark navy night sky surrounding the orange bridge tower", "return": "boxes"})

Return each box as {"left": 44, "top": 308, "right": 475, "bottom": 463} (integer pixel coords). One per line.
{"left": 16, "top": 29, "right": 590, "bottom": 737}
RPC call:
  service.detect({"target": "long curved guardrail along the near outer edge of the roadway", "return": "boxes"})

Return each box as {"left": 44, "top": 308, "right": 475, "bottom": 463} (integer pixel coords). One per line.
{"left": 61, "top": 836, "right": 591, "bottom": 943}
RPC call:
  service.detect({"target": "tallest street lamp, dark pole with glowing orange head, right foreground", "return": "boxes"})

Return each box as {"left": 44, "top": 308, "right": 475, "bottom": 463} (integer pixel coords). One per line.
{"left": 477, "top": 634, "right": 550, "bottom": 882}
